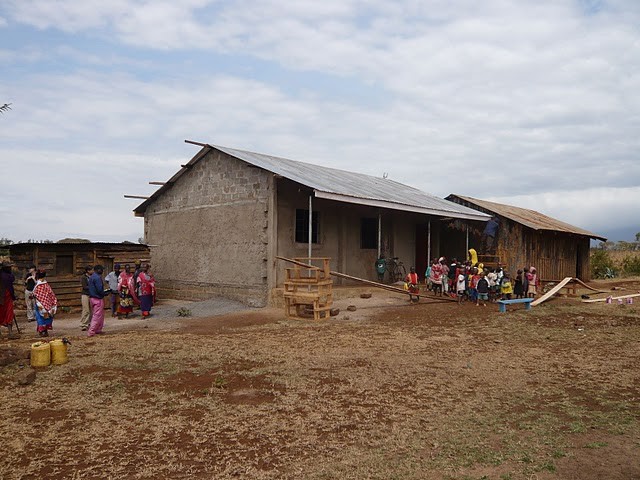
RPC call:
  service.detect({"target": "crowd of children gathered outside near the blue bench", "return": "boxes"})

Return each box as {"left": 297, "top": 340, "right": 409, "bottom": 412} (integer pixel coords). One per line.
{"left": 425, "top": 257, "right": 540, "bottom": 306}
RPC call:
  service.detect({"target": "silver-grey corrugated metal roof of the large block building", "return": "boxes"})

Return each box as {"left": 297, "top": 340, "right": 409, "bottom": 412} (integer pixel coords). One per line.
{"left": 135, "top": 145, "right": 489, "bottom": 220}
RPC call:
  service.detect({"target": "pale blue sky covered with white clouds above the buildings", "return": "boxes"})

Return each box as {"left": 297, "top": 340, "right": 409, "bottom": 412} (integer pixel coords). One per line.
{"left": 0, "top": 0, "right": 640, "bottom": 241}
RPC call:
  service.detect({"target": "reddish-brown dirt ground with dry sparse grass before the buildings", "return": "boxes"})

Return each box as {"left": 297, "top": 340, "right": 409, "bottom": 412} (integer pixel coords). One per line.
{"left": 0, "top": 279, "right": 640, "bottom": 480}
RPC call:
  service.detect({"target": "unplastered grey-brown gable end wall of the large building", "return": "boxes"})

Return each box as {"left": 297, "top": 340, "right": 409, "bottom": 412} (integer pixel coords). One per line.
{"left": 145, "top": 150, "right": 272, "bottom": 306}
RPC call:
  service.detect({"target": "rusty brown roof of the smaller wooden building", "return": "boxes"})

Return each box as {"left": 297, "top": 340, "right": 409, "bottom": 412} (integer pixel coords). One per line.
{"left": 447, "top": 193, "right": 607, "bottom": 241}
